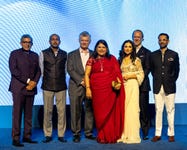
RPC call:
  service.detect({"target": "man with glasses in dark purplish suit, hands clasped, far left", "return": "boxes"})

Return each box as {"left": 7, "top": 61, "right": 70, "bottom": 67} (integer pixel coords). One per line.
{"left": 9, "top": 34, "right": 41, "bottom": 147}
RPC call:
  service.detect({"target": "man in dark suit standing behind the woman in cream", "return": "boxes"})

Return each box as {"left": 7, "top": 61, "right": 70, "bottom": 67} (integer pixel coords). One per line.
{"left": 132, "top": 30, "right": 151, "bottom": 140}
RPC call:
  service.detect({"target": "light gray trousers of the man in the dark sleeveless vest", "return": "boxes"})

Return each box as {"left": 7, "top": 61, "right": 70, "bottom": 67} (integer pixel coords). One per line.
{"left": 43, "top": 90, "right": 66, "bottom": 137}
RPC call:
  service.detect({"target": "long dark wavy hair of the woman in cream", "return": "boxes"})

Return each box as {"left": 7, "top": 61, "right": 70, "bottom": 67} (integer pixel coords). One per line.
{"left": 118, "top": 40, "right": 136, "bottom": 64}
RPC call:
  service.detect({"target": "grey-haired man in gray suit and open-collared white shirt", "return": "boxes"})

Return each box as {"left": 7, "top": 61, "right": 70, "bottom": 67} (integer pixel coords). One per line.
{"left": 67, "top": 31, "right": 95, "bottom": 142}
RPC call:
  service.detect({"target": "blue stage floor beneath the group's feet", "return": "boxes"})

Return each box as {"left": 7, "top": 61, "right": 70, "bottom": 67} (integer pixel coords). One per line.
{"left": 0, "top": 126, "right": 187, "bottom": 150}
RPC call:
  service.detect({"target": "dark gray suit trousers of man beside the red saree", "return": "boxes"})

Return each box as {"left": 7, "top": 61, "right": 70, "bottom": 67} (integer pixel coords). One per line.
{"left": 69, "top": 87, "right": 94, "bottom": 136}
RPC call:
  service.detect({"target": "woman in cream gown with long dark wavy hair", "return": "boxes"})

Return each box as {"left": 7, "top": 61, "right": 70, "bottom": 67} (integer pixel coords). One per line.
{"left": 118, "top": 40, "right": 144, "bottom": 143}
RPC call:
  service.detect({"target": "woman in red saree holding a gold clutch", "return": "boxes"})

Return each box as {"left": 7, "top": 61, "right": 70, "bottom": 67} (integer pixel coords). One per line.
{"left": 85, "top": 40, "right": 125, "bottom": 143}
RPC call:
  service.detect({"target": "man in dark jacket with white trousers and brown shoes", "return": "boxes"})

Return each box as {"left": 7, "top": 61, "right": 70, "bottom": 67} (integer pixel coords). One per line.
{"left": 151, "top": 33, "right": 179, "bottom": 142}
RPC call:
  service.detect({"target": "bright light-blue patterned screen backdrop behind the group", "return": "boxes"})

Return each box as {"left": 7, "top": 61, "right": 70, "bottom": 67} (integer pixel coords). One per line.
{"left": 0, "top": 0, "right": 187, "bottom": 106}
